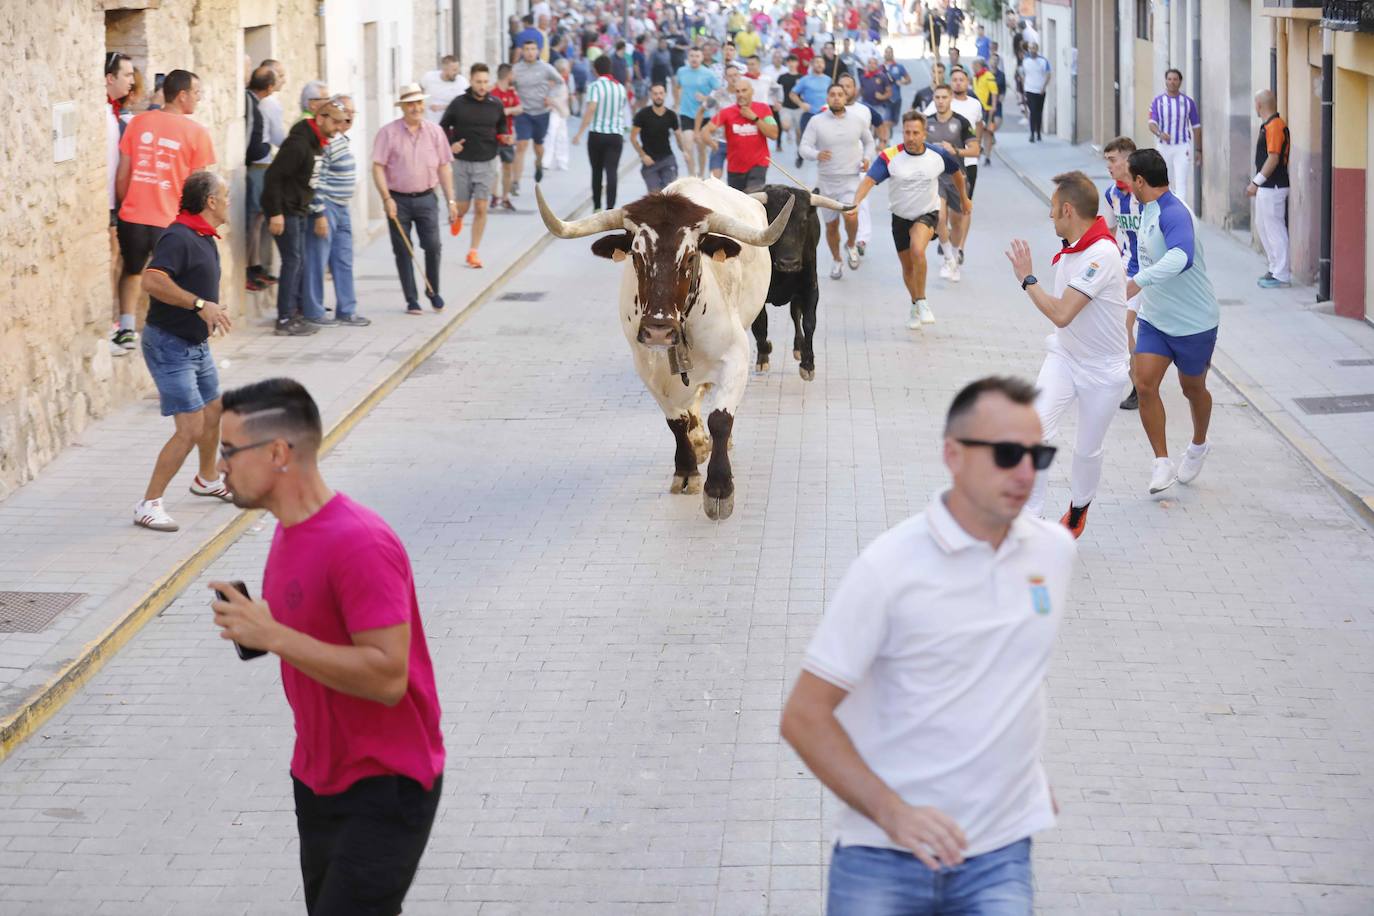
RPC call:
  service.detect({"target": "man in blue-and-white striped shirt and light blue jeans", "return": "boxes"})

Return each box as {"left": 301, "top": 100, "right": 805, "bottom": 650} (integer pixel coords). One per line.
{"left": 305, "top": 95, "right": 371, "bottom": 328}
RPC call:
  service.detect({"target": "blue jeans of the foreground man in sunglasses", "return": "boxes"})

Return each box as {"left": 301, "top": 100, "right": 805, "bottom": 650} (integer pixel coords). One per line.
{"left": 826, "top": 839, "right": 1032, "bottom": 916}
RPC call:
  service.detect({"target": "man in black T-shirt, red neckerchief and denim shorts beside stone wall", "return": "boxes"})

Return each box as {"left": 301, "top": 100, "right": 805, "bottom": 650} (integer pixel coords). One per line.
{"left": 133, "top": 169, "right": 232, "bottom": 531}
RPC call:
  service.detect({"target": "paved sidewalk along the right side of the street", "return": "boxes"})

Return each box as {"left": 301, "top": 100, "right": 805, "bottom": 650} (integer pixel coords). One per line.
{"left": 992, "top": 121, "right": 1374, "bottom": 523}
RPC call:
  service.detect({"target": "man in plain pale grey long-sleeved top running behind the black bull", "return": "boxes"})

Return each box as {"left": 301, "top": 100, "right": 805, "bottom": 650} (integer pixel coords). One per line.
{"left": 798, "top": 82, "right": 875, "bottom": 280}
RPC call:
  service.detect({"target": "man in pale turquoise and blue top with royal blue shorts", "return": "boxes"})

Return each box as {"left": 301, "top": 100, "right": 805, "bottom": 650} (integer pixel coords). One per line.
{"left": 1125, "top": 150, "right": 1221, "bottom": 493}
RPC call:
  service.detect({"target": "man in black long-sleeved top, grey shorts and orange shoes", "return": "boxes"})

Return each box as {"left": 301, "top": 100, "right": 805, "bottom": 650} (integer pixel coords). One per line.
{"left": 440, "top": 63, "right": 506, "bottom": 269}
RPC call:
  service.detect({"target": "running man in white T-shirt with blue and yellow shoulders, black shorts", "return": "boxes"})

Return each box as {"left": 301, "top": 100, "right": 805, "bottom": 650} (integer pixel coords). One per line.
{"left": 853, "top": 111, "right": 973, "bottom": 331}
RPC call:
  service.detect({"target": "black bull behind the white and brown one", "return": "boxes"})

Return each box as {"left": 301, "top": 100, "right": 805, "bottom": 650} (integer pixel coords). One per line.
{"left": 752, "top": 184, "right": 820, "bottom": 382}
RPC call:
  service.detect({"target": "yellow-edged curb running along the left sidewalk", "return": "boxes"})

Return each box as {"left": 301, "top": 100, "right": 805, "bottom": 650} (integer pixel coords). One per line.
{"left": 0, "top": 159, "right": 639, "bottom": 761}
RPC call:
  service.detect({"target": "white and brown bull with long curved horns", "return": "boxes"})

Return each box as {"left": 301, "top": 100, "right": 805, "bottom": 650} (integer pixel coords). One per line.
{"left": 534, "top": 179, "right": 791, "bottom": 519}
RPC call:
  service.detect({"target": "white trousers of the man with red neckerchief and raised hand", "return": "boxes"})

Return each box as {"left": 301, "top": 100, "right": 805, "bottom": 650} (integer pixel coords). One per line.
{"left": 1025, "top": 352, "right": 1129, "bottom": 516}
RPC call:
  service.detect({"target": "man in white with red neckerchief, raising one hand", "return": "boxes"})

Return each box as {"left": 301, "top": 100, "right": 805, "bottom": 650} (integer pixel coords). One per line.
{"left": 1007, "top": 172, "right": 1131, "bottom": 537}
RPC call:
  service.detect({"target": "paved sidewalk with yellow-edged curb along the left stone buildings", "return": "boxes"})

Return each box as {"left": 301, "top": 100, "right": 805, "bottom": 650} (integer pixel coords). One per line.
{"left": 0, "top": 147, "right": 642, "bottom": 759}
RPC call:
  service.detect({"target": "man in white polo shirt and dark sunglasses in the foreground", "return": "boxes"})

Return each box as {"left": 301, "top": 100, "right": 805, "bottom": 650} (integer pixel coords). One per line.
{"left": 782, "top": 378, "right": 1076, "bottom": 916}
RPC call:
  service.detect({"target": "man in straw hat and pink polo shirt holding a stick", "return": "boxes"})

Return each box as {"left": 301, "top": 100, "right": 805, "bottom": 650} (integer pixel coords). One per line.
{"left": 372, "top": 82, "right": 458, "bottom": 314}
